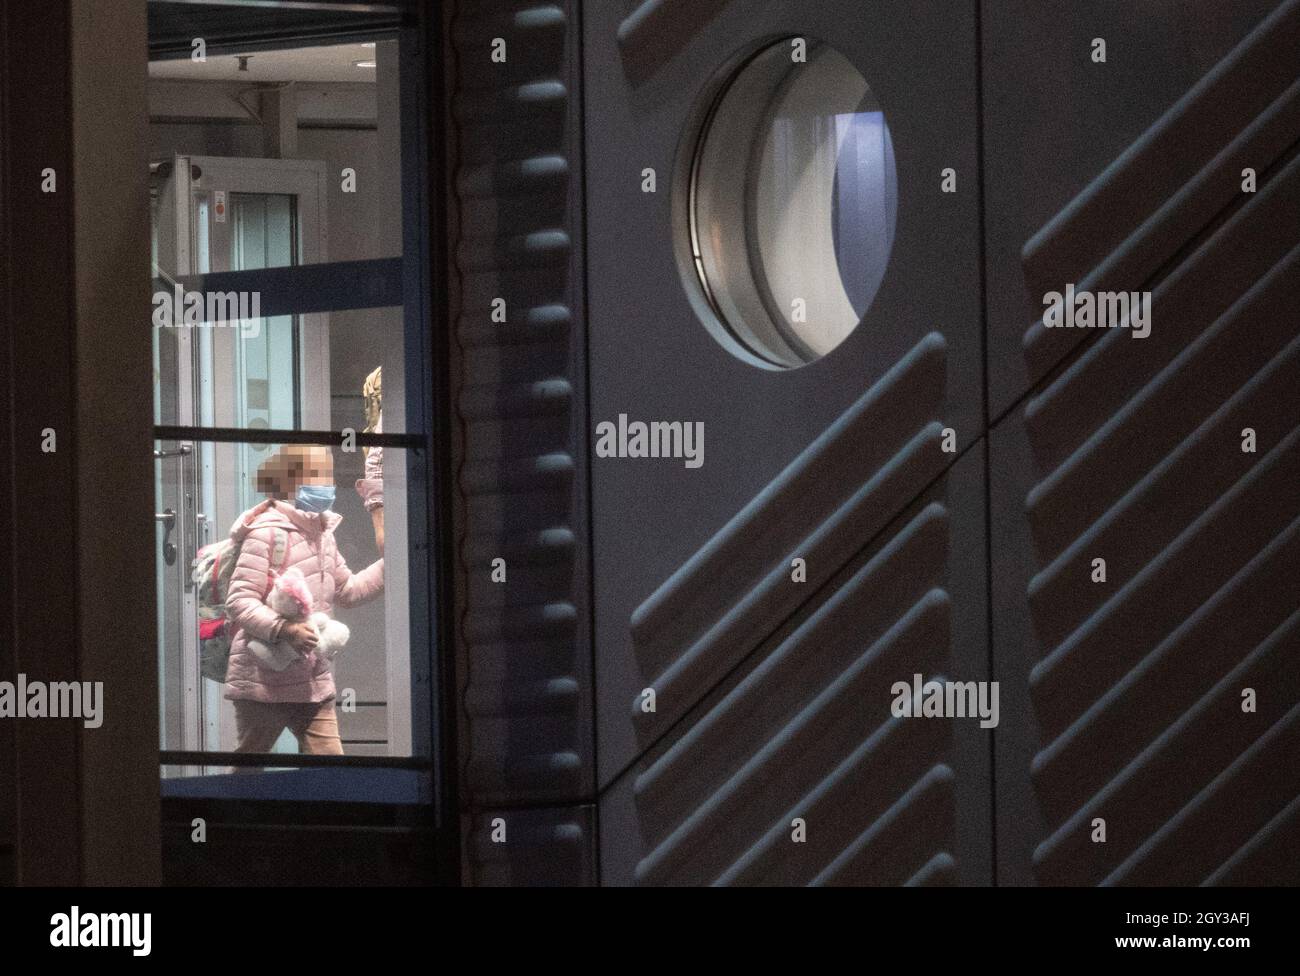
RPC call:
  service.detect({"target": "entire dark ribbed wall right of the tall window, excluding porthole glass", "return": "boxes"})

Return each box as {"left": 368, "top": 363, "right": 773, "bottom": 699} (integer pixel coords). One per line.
{"left": 455, "top": 0, "right": 1300, "bottom": 885}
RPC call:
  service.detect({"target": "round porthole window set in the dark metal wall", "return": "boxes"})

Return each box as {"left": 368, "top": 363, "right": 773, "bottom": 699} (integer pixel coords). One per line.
{"left": 688, "top": 38, "right": 898, "bottom": 368}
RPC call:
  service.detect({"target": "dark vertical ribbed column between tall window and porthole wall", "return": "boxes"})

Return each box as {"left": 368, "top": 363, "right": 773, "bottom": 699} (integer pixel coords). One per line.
{"left": 451, "top": 0, "right": 593, "bottom": 842}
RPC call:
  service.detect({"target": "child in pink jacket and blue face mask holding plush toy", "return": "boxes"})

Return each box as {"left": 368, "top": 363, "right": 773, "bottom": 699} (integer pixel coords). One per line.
{"left": 225, "top": 444, "right": 384, "bottom": 755}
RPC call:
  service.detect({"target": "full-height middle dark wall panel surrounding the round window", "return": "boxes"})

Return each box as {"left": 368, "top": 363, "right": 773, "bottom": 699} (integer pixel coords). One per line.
{"left": 584, "top": 1, "right": 991, "bottom": 884}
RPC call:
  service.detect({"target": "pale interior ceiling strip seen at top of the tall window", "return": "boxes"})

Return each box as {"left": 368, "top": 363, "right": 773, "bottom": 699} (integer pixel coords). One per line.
{"left": 150, "top": 43, "right": 374, "bottom": 83}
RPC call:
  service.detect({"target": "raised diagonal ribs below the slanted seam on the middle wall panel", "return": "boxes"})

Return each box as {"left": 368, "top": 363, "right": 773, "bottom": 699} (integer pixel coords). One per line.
{"left": 634, "top": 519, "right": 954, "bottom": 884}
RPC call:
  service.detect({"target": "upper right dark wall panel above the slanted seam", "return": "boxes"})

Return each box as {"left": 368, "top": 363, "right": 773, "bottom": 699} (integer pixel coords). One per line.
{"left": 980, "top": 0, "right": 1294, "bottom": 420}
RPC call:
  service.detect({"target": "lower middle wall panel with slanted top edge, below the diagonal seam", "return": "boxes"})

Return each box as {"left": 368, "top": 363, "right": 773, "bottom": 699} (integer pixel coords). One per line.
{"left": 601, "top": 444, "right": 992, "bottom": 885}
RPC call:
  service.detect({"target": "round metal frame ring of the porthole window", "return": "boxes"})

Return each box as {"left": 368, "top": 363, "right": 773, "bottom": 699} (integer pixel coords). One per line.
{"left": 671, "top": 32, "right": 900, "bottom": 370}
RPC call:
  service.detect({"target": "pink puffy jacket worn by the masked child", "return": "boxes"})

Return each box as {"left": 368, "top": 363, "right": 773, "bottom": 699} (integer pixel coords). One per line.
{"left": 225, "top": 502, "right": 384, "bottom": 702}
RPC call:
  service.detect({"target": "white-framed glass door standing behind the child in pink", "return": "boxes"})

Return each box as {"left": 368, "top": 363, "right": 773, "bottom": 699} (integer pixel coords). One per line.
{"left": 153, "top": 156, "right": 330, "bottom": 775}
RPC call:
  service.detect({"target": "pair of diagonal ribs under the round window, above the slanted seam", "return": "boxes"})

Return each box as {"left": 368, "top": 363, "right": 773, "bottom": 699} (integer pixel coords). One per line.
{"left": 628, "top": 333, "right": 946, "bottom": 741}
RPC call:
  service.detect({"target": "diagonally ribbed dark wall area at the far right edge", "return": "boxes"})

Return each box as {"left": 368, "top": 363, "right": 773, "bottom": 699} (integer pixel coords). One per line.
{"left": 995, "top": 0, "right": 1300, "bottom": 885}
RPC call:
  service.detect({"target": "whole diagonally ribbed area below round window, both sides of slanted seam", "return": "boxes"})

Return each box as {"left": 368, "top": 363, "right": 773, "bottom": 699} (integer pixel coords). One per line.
{"left": 602, "top": 343, "right": 989, "bottom": 885}
